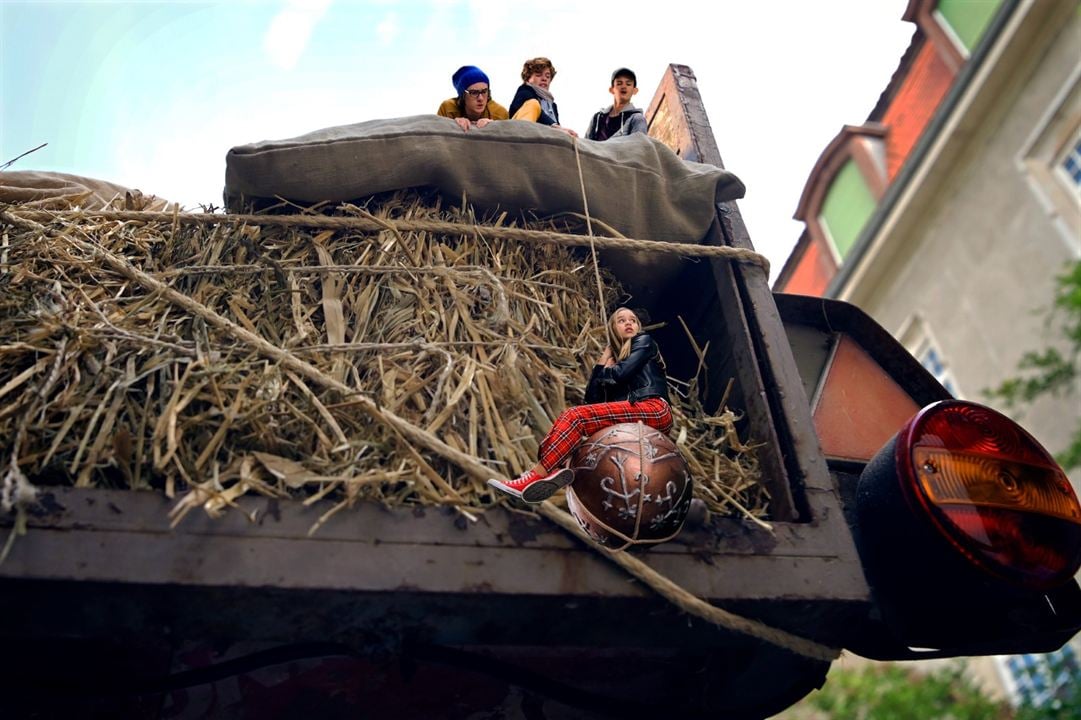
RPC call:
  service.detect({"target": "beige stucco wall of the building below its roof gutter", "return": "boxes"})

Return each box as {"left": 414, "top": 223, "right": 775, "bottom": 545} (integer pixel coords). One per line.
{"left": 846, "top": 2, "right": 1081, "bottom": 490}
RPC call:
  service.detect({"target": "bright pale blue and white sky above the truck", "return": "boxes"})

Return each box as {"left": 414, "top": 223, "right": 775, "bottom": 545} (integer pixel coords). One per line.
{"left": 0, "top": 0, "right": 916, "bottom": 275}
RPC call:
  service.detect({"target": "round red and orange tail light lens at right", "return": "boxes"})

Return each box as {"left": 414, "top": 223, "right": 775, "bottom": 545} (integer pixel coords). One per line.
{"left": 896, "top": 400, "right": 1081, "bottom": 589}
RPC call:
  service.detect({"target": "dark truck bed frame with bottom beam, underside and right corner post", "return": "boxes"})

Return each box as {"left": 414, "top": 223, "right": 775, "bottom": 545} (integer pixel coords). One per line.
{"left": 0, "top": 65, "right": 1081, "bottom": 718}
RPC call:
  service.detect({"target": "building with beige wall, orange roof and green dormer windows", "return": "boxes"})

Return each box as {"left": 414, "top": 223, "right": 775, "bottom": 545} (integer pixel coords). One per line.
{"left": 774, "top": 0, "right": 1081, "bottom": 701}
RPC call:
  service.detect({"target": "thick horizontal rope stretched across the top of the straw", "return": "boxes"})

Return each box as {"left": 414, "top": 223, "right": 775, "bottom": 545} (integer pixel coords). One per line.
{"left": 4, "top": 210, "right": 770, "bottom": 275}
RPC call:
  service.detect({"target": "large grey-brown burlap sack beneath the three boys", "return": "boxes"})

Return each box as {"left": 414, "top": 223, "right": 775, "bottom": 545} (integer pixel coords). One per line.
{"left": 225, "top": 115, "right": 744, "bottom": 242}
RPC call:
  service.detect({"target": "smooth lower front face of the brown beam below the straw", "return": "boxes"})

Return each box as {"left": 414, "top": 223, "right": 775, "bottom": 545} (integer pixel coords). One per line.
{"left": 0, "top": 521, "right": 866, "bottom": 605}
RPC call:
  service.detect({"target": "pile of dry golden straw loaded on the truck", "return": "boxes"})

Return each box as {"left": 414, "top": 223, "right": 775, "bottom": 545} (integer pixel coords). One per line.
{"left": 0, "top": 191, "right": 768, "bottom": 530}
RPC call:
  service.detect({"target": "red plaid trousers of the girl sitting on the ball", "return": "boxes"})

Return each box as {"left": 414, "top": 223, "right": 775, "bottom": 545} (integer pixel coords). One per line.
{"left": 537, "top": 398, "right": 672, "bottom": 470}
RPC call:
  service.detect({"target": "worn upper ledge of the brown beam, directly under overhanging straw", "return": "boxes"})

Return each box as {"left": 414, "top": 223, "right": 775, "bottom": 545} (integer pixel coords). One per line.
{"left": 14, "top": 488, "right": 851, "bottom": 557}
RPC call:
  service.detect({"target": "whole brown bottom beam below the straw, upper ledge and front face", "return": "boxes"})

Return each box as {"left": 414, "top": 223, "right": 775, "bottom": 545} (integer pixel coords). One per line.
{"left": 0, "top": 490, "right": 866, "bottom": 602}
